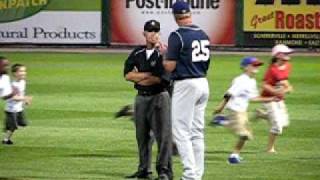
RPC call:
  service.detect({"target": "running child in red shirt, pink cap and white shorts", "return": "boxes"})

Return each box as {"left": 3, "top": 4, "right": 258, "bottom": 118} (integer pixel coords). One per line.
{"left": 261, "top": 44, "right": 293, "bottom": 153}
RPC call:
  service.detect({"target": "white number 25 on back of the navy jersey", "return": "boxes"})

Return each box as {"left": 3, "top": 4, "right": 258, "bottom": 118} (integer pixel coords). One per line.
{"left": 192, "top": 40, "right": 210, "bottom": 62}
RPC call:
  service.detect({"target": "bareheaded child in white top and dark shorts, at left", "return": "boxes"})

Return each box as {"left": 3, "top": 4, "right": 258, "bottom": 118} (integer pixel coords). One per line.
{"left": 2, "top": 64, "right": 32, "bottom": 144}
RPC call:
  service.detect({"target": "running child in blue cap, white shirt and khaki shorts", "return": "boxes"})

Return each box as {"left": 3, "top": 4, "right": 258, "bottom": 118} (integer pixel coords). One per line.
{"left": 215, "top": 57, "right": 274, "bottom": 164}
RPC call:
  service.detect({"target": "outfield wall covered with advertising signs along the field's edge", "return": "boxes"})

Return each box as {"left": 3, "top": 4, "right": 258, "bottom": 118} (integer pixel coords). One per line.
{"left": 0, "top": 0, "right": 320, "bottom": 48}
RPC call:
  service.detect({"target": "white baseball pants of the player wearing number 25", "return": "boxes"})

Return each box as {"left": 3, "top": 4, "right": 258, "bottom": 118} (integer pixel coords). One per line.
{"left": 172, "top": 78, "right": 209, "bottom": 180}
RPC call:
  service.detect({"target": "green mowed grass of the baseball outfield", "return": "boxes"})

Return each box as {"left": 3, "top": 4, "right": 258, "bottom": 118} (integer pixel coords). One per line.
{"left": 0, "top": 53, "right": 320, "bottom": 180}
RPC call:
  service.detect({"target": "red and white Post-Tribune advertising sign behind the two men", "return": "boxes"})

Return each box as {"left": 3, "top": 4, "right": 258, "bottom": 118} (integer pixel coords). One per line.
{"left": 110, "top": 0, "right": 236, "bottom": 45}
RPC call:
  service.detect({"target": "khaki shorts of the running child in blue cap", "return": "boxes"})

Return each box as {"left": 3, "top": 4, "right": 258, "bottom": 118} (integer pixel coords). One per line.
{"left": 226, "top": 109, "right": 252, "bottom": 140}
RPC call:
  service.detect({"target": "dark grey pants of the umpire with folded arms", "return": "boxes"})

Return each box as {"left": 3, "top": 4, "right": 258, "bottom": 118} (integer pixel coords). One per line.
{"left": 134, "top": 91, "right": 172, "bottom": 177}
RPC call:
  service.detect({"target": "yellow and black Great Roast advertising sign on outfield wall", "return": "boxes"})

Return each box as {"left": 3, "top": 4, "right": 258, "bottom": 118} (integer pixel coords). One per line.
{"left": 243, "top": 0, "right": 320, "bottom": 47}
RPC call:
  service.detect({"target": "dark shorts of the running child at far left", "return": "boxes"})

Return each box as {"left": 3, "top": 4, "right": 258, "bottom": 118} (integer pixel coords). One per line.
{"left": 5, "top": 111, "right": 27, "bottom": 131}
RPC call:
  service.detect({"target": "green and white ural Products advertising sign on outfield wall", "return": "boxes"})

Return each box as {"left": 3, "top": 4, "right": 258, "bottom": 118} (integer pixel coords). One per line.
{"left": 0, "top": 0, "right": 101, "bottom": 44}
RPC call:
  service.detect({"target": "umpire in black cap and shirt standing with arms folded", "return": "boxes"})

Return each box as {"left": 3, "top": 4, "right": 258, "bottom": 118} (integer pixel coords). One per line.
{"left": 124, "top": 20, "right": 173, "bottom": 179}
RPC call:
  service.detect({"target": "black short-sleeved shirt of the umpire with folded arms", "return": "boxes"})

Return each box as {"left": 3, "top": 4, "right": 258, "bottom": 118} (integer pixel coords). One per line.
{"left": 124, "top": 46, "right": 170, "bottom": 93}
